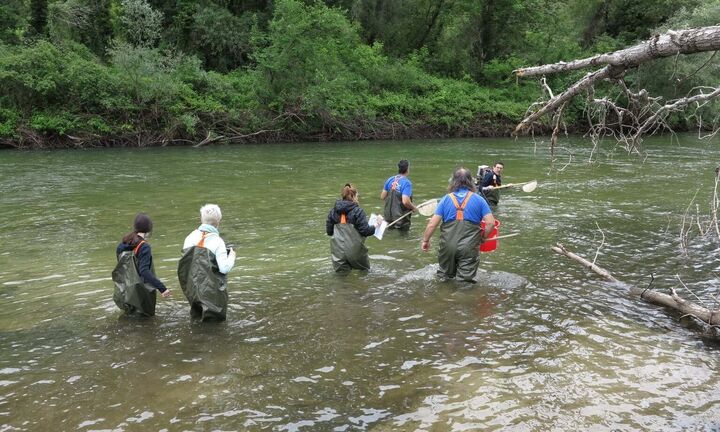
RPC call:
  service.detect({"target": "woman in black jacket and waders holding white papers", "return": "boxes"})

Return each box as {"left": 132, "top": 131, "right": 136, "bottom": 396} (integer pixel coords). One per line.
{"left": 325, "top": 183, "right": 382, "bottom": 273}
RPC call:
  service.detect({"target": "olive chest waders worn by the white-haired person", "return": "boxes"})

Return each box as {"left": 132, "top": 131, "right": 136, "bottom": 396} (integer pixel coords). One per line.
{"left": 178, "top": 232, "right": 228, "bottom": 321}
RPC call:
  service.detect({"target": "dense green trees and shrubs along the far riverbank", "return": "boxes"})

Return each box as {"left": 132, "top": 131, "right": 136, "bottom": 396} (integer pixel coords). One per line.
{"left": 0, "top": 0, "right": 720, "bottom": 148}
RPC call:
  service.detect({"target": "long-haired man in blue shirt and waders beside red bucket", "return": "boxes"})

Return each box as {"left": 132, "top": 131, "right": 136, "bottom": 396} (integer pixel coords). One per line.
{"left": 421, "top": 167, "right": 495, "bottom": 282}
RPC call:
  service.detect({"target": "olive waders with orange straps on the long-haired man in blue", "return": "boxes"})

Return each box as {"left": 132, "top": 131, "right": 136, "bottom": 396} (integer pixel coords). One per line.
{"left": 438, "top": 192, "right": 480, "bottom": 282}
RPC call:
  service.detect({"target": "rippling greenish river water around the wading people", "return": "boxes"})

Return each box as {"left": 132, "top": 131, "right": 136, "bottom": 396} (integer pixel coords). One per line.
{"left": 0, "top": 136, "right": 720, "bottom": 431}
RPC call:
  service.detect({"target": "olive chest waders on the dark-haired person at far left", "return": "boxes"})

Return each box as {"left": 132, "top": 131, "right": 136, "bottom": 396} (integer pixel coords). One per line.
{"left": 112, "top": 240, "right": 156, "bottom": 316}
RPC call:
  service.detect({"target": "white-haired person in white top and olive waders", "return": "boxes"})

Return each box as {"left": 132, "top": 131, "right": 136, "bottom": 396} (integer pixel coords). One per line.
{"left": 178, "top": 204, "right": 235, "bottom": 321}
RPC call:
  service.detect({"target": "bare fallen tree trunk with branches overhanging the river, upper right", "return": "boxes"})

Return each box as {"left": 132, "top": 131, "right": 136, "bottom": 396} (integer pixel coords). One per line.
{"left": 513, "top": 26, "right": 720, "bottom": 152}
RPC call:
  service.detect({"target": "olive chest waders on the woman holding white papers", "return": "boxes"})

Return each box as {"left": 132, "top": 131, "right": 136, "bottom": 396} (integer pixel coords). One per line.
{"left": 330, "top": 213, "right": 370, "bottom": 273}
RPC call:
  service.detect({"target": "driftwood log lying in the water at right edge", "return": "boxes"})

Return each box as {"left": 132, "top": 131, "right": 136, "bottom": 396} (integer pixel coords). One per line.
{"left": 552, "top": 243, "right": 720, "bottom": 326}
